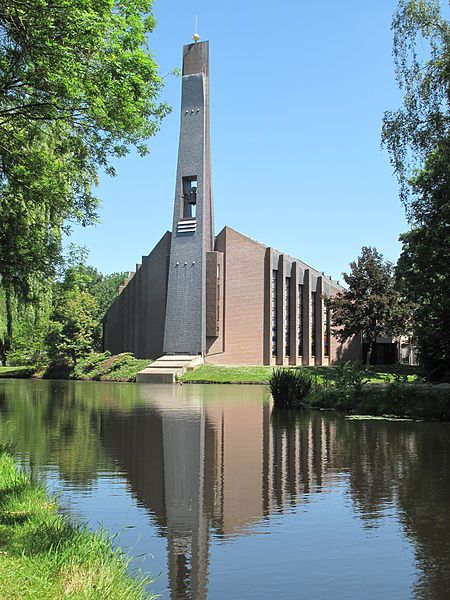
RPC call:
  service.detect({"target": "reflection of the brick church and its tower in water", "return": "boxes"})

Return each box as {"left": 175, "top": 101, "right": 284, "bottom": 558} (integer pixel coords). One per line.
{"left": 102, "top": 386, "right": 335, "bottom": 599}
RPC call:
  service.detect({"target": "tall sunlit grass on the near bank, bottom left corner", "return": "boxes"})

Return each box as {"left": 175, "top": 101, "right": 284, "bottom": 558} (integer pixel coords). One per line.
{"left": 0, "top": 449, "right": 154, "bottom": 600}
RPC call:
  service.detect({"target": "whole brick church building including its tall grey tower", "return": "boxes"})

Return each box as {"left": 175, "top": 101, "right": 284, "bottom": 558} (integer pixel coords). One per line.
{"left": 103, "top": 42, "right": 361, "bottom": 365}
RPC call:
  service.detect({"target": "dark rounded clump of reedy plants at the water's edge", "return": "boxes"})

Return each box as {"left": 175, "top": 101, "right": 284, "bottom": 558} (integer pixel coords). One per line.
{"left": 269, "top": 368, "right": 314, "bottom": 408}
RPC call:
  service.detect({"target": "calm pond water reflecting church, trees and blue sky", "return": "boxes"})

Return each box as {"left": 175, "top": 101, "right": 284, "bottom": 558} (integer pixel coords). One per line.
{"left": 0, "top": 380, "right": 450, "bottom": 600}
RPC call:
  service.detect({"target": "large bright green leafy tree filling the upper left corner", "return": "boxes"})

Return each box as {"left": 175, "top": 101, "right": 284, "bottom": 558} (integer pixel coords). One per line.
{"left": 0, "top": 0, "right": 168, "bottom": 326}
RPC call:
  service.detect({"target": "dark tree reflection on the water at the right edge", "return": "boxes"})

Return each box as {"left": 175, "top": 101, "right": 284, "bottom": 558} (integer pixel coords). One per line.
{"left": 333, "top": 419, "right": 450, "bottom": 599}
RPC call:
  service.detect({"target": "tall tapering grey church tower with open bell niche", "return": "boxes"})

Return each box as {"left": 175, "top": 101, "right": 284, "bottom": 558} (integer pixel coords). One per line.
{"left": 164, "top": 42, "right": 214, "bottom": 354}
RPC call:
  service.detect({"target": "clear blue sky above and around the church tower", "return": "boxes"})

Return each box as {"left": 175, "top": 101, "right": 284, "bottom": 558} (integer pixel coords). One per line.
{"left": 67, "top": 0, "right": 407, "bottom": 279}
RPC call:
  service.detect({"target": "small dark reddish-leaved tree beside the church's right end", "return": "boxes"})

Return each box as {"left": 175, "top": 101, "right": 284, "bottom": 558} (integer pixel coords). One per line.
{"left": 325, "top": 247, "right": 400, "bottom": 365}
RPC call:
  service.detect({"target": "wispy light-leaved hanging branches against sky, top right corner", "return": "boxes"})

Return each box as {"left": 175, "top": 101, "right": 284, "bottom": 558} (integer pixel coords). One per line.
{"left": 382, "top": 0, "right": 450, "bottom": 209}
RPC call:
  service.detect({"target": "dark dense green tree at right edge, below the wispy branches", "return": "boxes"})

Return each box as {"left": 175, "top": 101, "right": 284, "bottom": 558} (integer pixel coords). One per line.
{"left": 397, "top": 151, "right": 450, "bottom": 381}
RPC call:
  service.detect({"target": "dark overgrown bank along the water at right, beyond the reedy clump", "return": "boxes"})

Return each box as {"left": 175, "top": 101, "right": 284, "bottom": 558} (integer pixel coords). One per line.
{"left": 305, "top": 382, "right": 450, "bottom": 421}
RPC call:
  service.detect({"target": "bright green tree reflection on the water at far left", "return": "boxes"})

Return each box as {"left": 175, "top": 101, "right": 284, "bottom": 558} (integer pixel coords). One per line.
{"left": 0, "top": 381, "right": 144, "bottom": 487}
